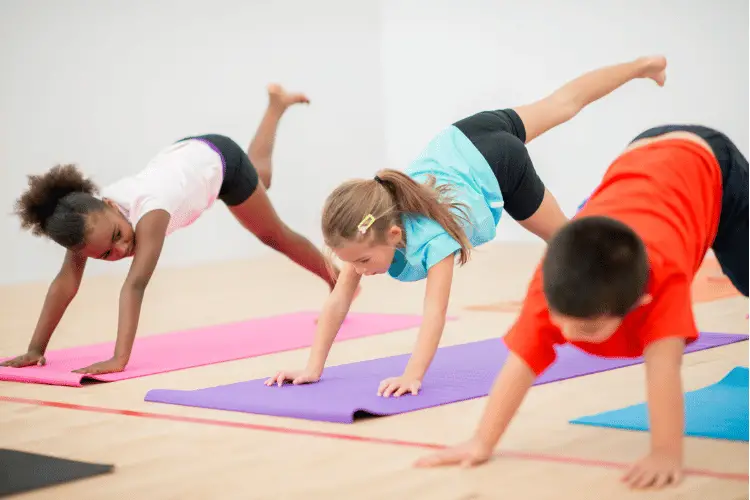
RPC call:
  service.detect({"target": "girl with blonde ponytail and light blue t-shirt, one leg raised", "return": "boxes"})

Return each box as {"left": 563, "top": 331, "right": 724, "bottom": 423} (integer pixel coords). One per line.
{"left": 266, "top": 57, "right": 666, "bottom": 397}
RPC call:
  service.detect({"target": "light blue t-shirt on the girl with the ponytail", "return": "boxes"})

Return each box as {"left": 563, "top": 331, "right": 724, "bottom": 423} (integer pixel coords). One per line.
{"left": 388, "top": 126, "right": 503, "bottom": 281}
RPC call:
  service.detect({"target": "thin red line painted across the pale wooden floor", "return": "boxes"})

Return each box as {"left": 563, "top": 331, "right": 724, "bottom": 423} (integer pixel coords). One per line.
{"left": 0, "top": 396, "right": 748, "bottom": 481}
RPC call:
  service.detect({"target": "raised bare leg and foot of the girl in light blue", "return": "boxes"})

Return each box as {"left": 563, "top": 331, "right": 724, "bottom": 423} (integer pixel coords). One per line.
{"left": 514, "top": 56, "right": 667, "bottom": 143}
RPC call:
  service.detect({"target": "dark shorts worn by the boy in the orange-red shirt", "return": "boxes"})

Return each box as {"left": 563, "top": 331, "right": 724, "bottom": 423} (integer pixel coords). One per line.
{"left": 633, "top": 125, "right": 750, "bottom": 297}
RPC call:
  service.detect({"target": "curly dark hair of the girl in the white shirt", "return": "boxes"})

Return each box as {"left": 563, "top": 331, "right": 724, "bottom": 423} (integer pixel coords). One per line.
{"left": 15, "top": 164, "right": 106, "bottom": 249}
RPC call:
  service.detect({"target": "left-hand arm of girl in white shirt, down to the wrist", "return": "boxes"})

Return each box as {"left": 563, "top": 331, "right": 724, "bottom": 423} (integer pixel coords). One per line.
{"left": 28, "top": 250, "right": 86, "bottom": 355}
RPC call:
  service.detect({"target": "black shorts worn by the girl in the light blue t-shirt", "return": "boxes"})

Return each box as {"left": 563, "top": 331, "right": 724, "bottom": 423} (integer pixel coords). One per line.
{"left": 453, "top": 109, "right": 545, "bottom": 221}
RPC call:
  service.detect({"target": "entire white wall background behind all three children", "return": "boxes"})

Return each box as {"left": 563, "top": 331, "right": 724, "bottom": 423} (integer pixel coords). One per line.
{"left": 0, "top": 0, "right": 748, "bottom": 283}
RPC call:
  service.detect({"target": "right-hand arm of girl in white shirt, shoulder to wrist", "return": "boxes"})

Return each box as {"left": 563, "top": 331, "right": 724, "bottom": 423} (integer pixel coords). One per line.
{"left": 114, "top": 210, "right": 170, "bottom": 366}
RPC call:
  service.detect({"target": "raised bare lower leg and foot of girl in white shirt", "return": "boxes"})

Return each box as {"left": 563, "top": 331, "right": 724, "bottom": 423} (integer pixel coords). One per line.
{"left": 247, "top": 83, "right": 310, "bottom": 189}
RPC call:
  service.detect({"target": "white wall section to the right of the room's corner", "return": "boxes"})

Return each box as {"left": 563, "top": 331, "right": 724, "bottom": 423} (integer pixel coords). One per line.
{"left": 382, "top": 0, "right": 749, "bottom": 241}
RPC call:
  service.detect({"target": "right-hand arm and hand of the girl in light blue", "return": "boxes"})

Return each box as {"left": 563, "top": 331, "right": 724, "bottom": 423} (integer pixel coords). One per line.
{"left": 378, "top": 254, "right": 455, "bottom": 397}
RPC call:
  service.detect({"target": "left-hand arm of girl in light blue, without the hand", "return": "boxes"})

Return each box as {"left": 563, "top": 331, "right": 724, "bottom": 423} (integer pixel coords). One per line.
{"left": 307, "top": 264, "right": 361, "bottom": 374}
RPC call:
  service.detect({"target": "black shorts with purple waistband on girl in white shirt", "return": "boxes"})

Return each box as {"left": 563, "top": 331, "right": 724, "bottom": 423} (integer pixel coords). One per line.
{"left": 177, "top": 134, "right": 259, "bottom": 207}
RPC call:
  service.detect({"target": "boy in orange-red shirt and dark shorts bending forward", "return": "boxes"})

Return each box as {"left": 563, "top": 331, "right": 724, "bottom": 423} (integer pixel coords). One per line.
{"left": 417, "top": 125, "right": 749, "bottom": 488}
